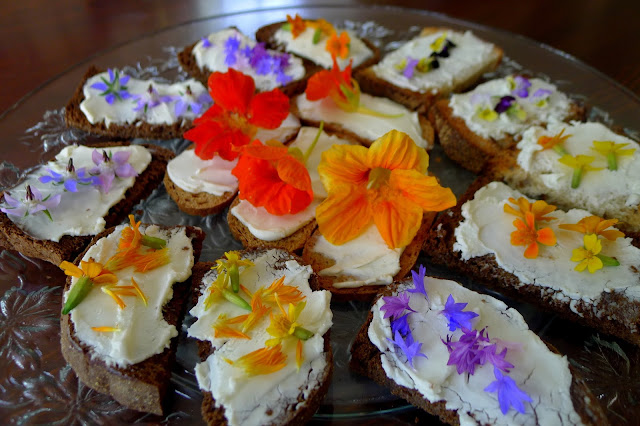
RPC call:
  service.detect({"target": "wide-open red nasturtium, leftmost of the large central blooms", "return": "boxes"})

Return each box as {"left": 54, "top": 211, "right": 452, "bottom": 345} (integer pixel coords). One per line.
{"left": 184, "top": 68, "right": 289, "bottom": 161}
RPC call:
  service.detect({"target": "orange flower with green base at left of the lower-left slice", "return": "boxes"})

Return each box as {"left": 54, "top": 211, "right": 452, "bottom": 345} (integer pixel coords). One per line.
{"left": 60, "top": 259, "right": 118, "bottom": 315}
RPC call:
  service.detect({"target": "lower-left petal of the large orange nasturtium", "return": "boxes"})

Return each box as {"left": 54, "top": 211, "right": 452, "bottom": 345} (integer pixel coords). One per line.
{"left": 316, "top": 186, "right": 373, "bottom": 245}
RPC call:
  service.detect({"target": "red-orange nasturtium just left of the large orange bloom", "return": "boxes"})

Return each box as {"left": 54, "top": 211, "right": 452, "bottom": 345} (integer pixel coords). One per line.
{"left": 231, "top": 141, "right": 313, "bottom": 215}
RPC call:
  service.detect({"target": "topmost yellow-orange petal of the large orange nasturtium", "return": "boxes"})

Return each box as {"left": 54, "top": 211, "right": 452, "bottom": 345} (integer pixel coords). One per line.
{"left": 367, "top": 130, "right": 429, "bottom": 174}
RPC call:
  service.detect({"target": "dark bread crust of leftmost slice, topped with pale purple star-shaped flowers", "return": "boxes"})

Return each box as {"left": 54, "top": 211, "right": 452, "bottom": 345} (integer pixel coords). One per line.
{"left": 0, "top": 142, "right": 174, "bottom": 265}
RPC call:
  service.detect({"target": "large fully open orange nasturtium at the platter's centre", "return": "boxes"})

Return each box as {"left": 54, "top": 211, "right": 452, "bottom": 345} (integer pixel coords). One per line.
{"left": 316, "top": 130, "right": 456, "bottom": 248}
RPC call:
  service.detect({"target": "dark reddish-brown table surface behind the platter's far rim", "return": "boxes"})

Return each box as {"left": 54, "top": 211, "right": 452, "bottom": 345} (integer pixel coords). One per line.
{"left": 0, "top": 0, "right": 640, "bottom": 117}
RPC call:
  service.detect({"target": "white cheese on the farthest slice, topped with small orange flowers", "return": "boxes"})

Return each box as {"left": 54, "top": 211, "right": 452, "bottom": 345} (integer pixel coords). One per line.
{"left": 273, "top": 26, "right": 373, "bottom": 69}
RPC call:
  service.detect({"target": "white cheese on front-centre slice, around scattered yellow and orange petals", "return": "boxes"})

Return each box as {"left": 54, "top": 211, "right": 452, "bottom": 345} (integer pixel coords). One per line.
{"left": 188, "top": 250, "right": 332, "bottom": 425}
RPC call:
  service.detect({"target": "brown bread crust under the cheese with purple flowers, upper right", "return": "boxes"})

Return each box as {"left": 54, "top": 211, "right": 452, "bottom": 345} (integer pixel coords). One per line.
{"left": 429, "top": 99, "right": 587, "bottom": 173}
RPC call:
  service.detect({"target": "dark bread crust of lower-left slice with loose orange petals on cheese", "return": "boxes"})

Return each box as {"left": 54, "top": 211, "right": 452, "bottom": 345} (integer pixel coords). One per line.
{"left": 60, "top": 226, "right": 205, "bottom": 415}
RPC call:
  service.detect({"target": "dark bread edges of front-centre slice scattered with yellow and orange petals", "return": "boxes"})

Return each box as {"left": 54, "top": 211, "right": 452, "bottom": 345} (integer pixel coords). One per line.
{"left": 192, "top": 249, "right": 333, "bottom": 425}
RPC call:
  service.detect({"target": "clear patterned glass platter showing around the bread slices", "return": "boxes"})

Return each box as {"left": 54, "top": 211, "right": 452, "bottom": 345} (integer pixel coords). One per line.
{"left": 0, "top": 6, "right": 640, "bottom": 424}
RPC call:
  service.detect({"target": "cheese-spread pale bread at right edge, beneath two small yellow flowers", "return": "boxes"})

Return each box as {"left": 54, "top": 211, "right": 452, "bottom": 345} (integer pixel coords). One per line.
{"left": 507, "top": 122, "right": 640, "bottom": 230}
